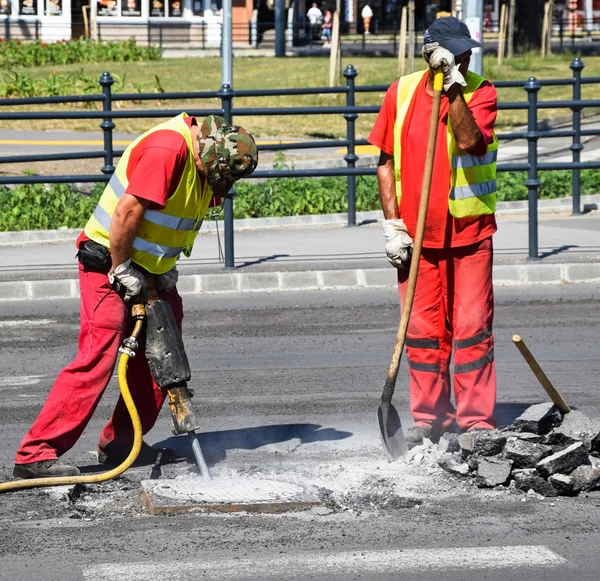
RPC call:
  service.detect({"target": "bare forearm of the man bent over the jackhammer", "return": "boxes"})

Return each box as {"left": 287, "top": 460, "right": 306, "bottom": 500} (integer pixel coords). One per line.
{"left": 109, "top": 194, "right": 150, "bottom": 268}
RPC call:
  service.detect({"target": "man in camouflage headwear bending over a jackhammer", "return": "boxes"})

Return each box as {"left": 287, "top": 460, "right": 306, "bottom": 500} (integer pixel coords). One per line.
{"left": 14, "top": 113, "right": 258, "bottom": 478}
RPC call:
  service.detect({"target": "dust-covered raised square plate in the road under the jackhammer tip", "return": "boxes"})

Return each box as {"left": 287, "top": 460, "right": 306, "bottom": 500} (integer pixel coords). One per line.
{"left": 141, "top": 476, "right": 325, "bottom": 514}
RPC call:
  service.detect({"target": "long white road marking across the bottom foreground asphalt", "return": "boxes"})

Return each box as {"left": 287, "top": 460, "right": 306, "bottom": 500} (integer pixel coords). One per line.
{"left": 83, "top": 545, "right": 567, "bottom": 581}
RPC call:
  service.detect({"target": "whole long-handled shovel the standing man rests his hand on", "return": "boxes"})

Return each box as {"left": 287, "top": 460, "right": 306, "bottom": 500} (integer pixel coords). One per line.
{"left": 377, "top": 69, "right": 444, "bottom": 462}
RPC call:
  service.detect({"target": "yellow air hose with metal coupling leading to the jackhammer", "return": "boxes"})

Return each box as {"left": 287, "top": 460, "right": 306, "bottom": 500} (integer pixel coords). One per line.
{"left": 0, "top": 304, "right": 146, "bottom": 492}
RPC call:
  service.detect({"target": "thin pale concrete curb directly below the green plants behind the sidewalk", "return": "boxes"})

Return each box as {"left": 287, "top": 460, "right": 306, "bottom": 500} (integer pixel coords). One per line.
{"left": 0, "top": 194, "right": 600, "bottom": 246}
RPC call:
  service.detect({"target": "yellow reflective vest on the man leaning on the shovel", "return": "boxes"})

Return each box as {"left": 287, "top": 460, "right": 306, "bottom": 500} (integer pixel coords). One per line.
{"left": 394, "top": 71, "right": 498, "bottom": 218}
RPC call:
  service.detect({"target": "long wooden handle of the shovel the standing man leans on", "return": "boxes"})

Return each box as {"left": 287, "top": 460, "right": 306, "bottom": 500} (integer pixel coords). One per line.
{"left": 381, "top": 69, "right": 444, "bottom": 403}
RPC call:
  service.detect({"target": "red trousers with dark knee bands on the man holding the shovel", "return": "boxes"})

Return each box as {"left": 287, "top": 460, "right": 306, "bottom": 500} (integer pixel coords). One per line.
{"left": 398, "top": 238, "right": 496, "bottom": 431}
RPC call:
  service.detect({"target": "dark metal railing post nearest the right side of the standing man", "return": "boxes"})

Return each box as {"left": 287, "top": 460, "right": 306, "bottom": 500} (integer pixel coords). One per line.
{"left": 524, "top": 77, "right": 542, "bottom": 260}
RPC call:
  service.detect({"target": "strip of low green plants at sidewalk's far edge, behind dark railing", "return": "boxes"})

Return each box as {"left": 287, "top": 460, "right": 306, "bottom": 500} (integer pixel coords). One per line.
{"left": 0, "top": 162, "right": 600, "bottom": 231}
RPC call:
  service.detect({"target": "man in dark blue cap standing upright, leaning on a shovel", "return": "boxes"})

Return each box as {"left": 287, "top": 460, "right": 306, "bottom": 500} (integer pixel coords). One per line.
{"left": 369, "top": 17, "right": 498, "bottom": 447}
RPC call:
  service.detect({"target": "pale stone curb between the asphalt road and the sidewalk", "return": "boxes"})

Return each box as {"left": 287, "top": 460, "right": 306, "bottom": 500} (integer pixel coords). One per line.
{"left": 0, "top": 263, "right": 600, "bottom": 301}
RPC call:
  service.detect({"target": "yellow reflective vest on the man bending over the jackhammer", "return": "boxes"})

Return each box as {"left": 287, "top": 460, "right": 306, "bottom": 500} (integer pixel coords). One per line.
{"left": 85, "top": 113, "right": 213, "bottom": 274}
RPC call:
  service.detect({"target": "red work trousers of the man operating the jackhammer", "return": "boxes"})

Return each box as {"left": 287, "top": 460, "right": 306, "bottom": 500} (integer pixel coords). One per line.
{"left": 16, "top": 265, "right": 183, "bottom": 464}
